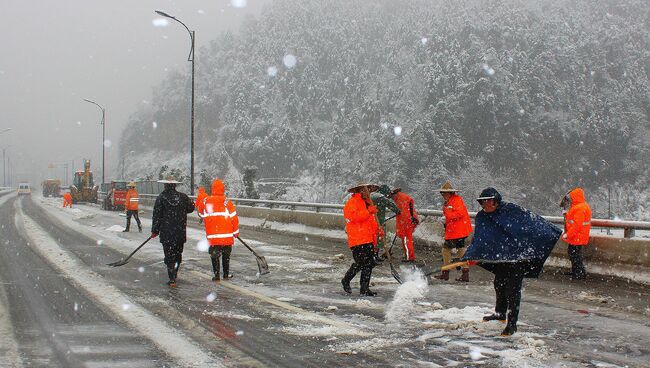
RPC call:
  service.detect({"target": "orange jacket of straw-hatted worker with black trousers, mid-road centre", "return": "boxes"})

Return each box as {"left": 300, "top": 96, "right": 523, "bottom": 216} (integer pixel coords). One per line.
{"left": 343, "top": 193, "right": 379, "bottom": 248}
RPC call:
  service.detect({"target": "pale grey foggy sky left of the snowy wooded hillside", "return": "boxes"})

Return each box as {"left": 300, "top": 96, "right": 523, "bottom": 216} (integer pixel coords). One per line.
{"left": 0, "top": 0, "right": 270, "bottom": 186}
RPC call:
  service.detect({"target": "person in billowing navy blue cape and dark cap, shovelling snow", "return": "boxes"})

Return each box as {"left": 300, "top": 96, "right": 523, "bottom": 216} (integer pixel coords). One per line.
{"left": 463, "top": 188, "right": 562, "bottom": 336}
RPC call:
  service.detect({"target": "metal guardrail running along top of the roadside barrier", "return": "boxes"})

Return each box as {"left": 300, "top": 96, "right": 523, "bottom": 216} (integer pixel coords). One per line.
{"left": 114, "top": 193, "right": 650, "bottom": 238}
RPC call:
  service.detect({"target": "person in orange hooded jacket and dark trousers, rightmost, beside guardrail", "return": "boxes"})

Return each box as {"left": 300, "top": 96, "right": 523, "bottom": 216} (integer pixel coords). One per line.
{"left": 561, "top": 188, "right": 591, "bottom": 280}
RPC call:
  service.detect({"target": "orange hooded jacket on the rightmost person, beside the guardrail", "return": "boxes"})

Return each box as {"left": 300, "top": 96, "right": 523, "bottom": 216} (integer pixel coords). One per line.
{"left": 562, "top": 188, "right": 591, "bottom": 245}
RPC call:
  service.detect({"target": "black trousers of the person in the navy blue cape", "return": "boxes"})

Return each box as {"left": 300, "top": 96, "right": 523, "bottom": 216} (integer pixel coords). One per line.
{"left": 493, "top": 263, "right": 524, "bottom": 326}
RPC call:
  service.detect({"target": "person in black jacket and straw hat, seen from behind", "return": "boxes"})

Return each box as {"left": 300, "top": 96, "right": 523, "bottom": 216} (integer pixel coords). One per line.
{"left": 151, "top": 176, "right": 194, "bottom": 287}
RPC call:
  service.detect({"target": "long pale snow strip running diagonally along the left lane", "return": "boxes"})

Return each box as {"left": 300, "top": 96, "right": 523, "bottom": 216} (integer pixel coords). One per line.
{"left": 16, "top": 197, "right": 224, "bottom": 367}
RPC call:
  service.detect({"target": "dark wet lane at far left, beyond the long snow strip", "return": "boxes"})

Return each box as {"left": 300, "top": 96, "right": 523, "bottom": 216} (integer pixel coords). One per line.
{"left": 0, "top": 196, "right": 175, "bottom": 367}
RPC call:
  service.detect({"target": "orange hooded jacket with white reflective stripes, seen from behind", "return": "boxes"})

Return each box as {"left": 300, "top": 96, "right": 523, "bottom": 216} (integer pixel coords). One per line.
{"left": 197, "top": 179, "right": 239, "bottom": 246}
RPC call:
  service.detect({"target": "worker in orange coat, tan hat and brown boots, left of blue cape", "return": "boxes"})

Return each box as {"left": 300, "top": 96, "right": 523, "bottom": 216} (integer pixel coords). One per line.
{"left": 434, "top": 182, "right": 472, "bottom": 282}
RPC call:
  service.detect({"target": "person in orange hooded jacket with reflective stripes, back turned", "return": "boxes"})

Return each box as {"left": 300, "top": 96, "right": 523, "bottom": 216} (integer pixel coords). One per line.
{"left": 196, "top": 179, "right": 239, "bottom": 281}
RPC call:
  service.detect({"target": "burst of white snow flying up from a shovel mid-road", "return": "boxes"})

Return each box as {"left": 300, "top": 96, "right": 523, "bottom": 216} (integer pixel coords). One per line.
{"left": 385, "top": 269, "right": 428, "bottom": 322}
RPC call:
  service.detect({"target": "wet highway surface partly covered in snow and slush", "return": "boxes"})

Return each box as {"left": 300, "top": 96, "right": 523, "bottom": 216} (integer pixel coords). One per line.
{"left": 0, "top": 193, "right": 650, "bottom": 367}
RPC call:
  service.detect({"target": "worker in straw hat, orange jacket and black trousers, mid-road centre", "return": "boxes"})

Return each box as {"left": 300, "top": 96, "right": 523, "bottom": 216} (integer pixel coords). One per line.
{"left": 341, "top": 184, "right": 379, "bottom": 296}
